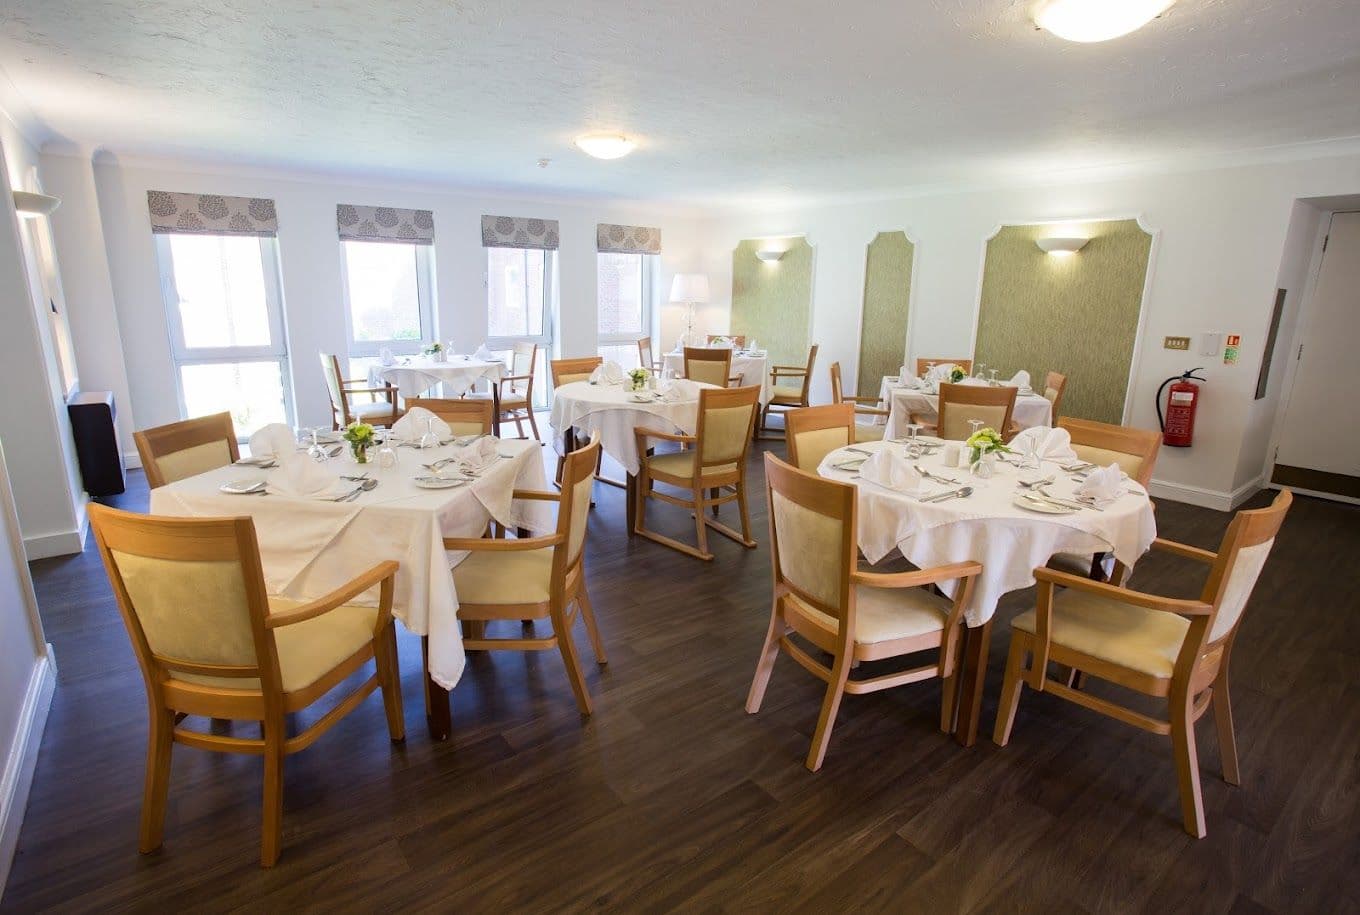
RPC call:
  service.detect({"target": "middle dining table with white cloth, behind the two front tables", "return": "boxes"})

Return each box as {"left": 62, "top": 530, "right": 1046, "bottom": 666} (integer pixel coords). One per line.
{"left": 548, "top": 381, "right": 717, "bottom": 527}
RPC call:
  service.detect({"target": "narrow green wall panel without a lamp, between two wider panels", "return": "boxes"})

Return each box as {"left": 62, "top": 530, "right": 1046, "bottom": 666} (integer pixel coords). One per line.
{"left": 855, "top": 231, "right": 915, "bottom": 396}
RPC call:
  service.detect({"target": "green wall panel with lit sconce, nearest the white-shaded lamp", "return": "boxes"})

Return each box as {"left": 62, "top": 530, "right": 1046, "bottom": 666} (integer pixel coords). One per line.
{"left": 732, "top": 238, "right": 812, "bottom": 366}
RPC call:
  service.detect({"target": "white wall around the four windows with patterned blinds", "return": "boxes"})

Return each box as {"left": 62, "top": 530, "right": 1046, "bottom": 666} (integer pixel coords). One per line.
{"left": 54, "top": 149, "right": 710, "bottom": 428}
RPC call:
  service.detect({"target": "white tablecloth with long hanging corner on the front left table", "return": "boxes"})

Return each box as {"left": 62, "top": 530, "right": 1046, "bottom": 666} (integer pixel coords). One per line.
{"left": 151, "top": 439, "right": 555, "bottom": 689}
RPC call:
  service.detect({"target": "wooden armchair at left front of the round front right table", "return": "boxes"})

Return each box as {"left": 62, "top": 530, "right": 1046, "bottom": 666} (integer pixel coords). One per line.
{"left": 747, "top": 453, "right": 982, "bottom": 772}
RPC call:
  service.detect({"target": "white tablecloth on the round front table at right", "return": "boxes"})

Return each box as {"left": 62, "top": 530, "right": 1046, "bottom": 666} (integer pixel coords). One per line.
{"left": 817, "top": 442, "right": 1157, "bottom": 625}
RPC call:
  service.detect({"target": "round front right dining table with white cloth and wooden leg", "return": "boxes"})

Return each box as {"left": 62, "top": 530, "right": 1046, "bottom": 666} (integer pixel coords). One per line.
{"left": 817, "top": 436, "right": 1157, "bottom": 746}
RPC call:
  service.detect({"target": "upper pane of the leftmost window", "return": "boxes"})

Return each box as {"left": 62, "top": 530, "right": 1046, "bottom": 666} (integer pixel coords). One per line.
{"left": 166, "top": 234, "right": 269, "bottom": 348}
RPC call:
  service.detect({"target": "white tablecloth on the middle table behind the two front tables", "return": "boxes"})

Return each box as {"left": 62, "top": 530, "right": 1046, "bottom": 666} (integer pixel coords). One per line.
{"left": 549, "top": 381, "right": 713, "bottom": 474}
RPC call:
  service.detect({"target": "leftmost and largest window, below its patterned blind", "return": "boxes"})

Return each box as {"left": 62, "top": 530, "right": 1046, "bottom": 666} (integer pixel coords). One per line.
{"left": 155, "top": 232, "right": 291, "bottom": 441}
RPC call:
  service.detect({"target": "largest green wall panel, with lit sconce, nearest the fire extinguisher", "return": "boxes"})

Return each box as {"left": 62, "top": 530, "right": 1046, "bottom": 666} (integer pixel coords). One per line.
{"left": 974, "top": 219, "right": 1152, "bottom": 423}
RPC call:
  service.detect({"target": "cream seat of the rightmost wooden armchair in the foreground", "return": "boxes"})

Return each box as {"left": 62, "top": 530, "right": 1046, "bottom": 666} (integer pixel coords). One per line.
{"left": 1012, "top": 592, "right": 1190, "bottom": 680}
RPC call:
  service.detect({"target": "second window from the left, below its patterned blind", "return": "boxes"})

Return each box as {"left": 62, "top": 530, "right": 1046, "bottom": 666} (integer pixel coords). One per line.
{"left": 340, "top": 239, "right": 435, "bottom": 378}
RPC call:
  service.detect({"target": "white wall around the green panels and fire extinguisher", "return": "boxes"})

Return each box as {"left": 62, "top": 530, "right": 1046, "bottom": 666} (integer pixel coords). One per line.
{"left": 714, "top": 156, "right": 1360, "bottom": 508}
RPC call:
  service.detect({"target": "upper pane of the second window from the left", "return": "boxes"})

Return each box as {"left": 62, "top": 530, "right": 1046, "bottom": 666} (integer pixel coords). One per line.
{"left": 344, "top": 242, "right": 424, "bottom": 343}
